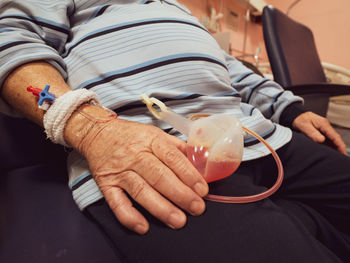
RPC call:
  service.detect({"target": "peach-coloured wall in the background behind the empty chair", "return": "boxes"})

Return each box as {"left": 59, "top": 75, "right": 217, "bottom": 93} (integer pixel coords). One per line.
{"left": 179, "top": 0, "right": 350, "bottom": 69}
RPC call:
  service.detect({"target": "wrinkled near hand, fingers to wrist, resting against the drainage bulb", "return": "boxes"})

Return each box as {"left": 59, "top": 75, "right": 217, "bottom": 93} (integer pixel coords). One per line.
{"left": 65, "top": 105, "right": 208, "bottom": 234}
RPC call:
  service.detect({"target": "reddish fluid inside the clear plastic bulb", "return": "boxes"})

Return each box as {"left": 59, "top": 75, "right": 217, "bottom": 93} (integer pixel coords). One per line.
{"left": 186, "top": 146, "right": 240, "bottom": 183}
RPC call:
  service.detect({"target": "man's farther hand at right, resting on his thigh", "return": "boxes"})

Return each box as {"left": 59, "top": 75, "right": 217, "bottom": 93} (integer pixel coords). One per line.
{"left": 293, "top": 111, "right": 347, "bottom": 154}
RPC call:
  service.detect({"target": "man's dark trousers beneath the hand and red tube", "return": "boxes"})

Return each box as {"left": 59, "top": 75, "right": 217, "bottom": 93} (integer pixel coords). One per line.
{"left": 86, "top": 133, "right": 350, "bottom": 263}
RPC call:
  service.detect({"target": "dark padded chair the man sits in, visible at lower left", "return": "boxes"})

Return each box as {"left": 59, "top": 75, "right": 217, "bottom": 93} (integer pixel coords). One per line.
{"left": 0, "top": 113, "right": 121, "bottom": 263}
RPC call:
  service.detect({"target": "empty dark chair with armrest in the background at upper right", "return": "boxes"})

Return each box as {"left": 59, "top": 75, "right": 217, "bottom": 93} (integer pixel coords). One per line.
{"left": 262, "top": 6, "right": 350, "bottom": 117}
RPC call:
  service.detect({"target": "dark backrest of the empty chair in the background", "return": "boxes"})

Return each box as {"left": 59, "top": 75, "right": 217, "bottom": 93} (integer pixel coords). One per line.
{"left": 262, "top": 6, "right": 327, "bottom": 87}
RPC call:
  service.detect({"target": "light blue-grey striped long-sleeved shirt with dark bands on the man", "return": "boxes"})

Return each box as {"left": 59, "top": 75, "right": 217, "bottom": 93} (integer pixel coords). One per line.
{"left": 0, "top": 0, "right": 302, "bottom": 209}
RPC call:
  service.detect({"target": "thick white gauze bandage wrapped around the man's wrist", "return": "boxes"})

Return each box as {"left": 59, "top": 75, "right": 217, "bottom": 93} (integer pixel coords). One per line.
{"left": 43, "top": 89, "right": 101, "bottom": 147}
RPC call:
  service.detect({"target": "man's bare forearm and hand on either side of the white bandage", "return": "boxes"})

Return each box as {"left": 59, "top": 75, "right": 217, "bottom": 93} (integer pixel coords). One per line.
{"left": 1, "top": 61, "right": 208, "bottom": 234}
